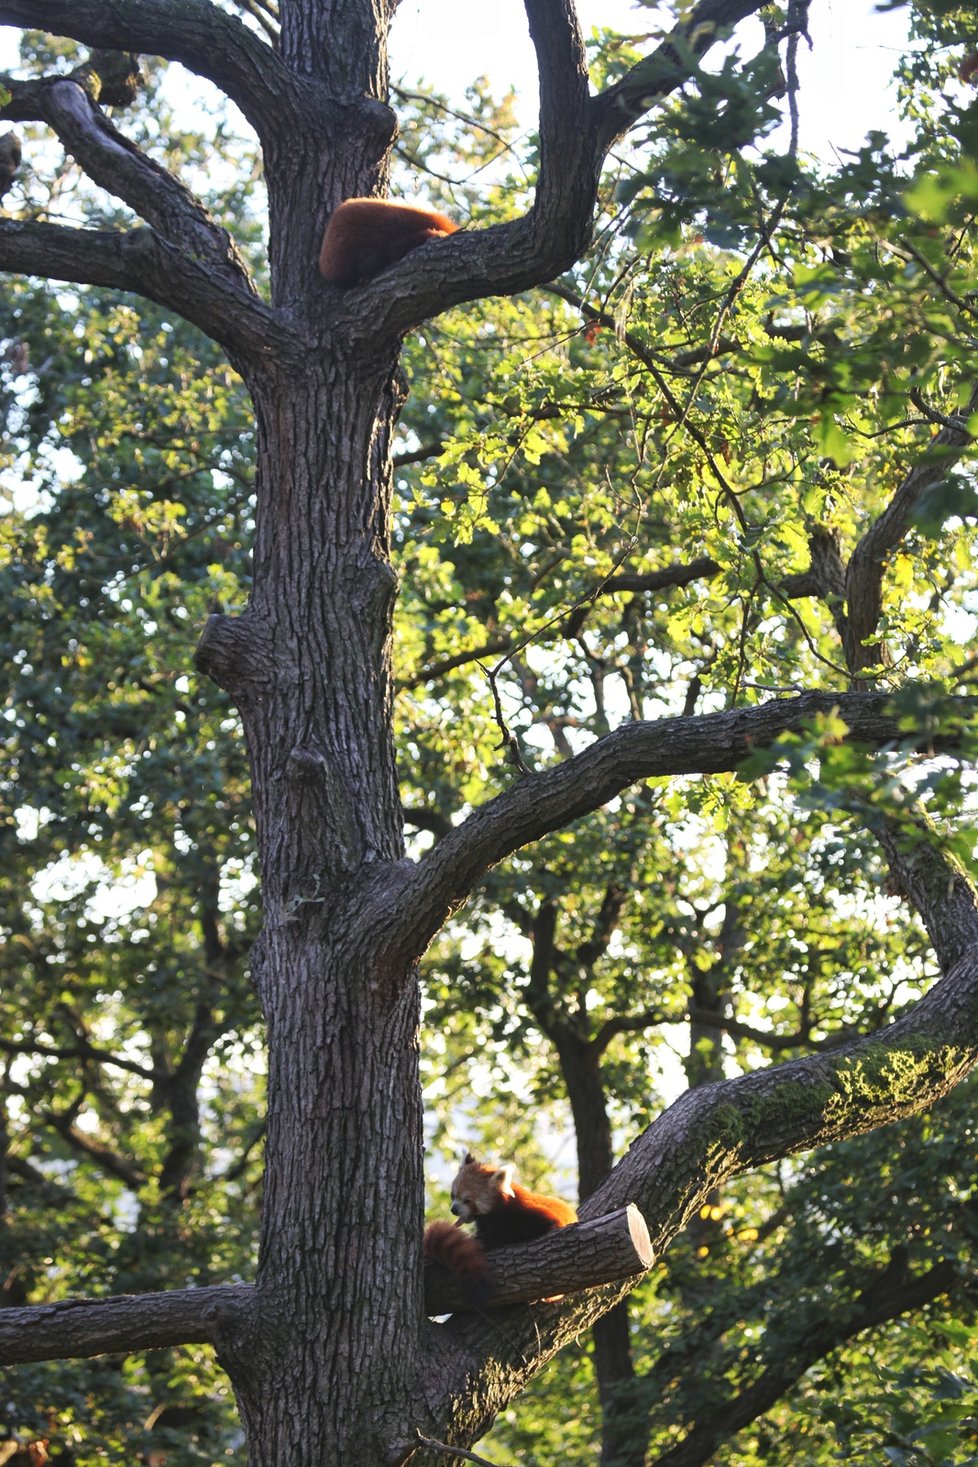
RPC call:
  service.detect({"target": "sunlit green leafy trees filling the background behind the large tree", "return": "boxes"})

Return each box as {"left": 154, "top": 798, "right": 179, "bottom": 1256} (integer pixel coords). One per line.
{"left": 0, "top": 0, "right": 977, "bottom": 1463}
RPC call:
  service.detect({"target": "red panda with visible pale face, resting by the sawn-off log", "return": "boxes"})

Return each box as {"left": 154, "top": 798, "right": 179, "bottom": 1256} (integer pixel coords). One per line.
{"left": 424, "top": 1152, "right": 578, "bottom": 1300}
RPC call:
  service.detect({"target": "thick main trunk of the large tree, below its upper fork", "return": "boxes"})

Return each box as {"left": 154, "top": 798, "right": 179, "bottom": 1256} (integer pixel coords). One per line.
{"left": 199, "top": 352, "right": 424, "bottom": 1467}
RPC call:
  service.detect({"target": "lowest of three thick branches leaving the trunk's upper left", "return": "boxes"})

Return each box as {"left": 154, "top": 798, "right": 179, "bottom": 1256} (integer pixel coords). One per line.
{"left": 0, "top": 219, "right": 308, "bottom": 362}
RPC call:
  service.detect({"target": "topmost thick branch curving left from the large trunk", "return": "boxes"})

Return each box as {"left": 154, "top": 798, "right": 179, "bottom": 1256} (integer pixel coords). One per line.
{"left": 0, "top": 0, "right": 298, "bottom": 136}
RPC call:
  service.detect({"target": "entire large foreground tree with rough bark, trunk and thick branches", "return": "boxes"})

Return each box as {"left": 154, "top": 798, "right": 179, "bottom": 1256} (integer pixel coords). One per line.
{"left": 0, "top": 0, "right": 978, "bottom": 1467}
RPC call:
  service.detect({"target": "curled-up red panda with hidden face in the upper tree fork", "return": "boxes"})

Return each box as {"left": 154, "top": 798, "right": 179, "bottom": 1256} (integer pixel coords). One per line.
{"left": 320, "top": 198, "right": 459, "bottom": 288}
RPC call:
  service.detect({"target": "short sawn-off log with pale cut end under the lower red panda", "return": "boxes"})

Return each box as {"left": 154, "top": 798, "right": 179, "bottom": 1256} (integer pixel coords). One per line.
{"left": 425, "top": 1207, "right": 652, "bottom": 1314}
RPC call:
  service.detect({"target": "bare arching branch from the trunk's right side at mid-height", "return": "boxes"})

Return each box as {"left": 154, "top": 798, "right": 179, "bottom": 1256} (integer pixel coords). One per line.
{"left": 405, "top": 692, "right": 961, "bottom": 942}
